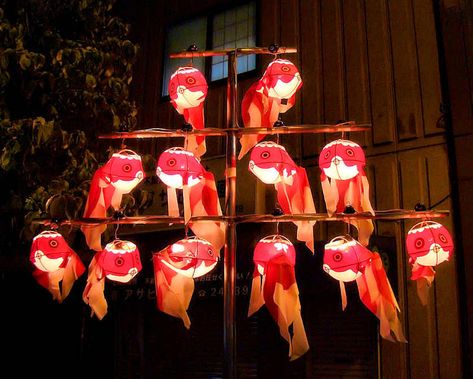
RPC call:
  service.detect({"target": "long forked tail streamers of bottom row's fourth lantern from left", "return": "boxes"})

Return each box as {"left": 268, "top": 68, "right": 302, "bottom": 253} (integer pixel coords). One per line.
{"left": 248, "top": 257, "right": 309, "bottom": 361}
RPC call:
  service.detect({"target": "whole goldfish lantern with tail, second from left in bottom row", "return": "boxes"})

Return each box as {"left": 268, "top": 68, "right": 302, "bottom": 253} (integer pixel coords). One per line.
{"left": 82, "top": 239, "right": 142, "bottom": 320}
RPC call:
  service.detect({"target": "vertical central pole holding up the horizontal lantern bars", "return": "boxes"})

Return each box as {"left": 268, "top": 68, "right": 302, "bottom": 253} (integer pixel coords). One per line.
{"left": 223, "top": 50, "right": 238, "bottom": 379}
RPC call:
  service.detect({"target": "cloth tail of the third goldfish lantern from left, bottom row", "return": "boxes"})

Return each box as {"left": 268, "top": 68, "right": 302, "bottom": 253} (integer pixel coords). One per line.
{"left": 153, "top": 249, "right": 194, "bottom": 329}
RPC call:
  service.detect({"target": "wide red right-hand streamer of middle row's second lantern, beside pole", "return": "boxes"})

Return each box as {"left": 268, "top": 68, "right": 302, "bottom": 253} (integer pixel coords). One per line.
{"left": 189, "top": 171, "right": 225, "bottom": 256}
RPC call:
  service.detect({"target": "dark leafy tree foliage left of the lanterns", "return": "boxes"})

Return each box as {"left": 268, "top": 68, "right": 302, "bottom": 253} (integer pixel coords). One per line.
{"left": 0, "top": 0, "right": 138, "bottom": 252}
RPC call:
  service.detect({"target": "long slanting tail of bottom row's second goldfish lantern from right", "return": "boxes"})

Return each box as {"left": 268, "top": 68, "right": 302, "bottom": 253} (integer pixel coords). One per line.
{"left": 356, "top": 253, "right": 407, "bottom": 342}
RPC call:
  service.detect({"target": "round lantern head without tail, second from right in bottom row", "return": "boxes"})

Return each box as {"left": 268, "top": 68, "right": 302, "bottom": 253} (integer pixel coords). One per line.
{"left": 322, "top": 236, "right": 372, "bottom": 282}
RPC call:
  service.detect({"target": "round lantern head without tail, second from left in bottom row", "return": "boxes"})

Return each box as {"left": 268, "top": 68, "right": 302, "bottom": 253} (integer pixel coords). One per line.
{"left": 98, "top": 240, "right": 142, "bottom": 283}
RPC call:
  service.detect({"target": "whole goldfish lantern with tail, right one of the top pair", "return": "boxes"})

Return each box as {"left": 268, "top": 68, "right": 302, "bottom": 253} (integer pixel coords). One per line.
{"left": 238, "top": 59, "right": 302, "bottom": 159}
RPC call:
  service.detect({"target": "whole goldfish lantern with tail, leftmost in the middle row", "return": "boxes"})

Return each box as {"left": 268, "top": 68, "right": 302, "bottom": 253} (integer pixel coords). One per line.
{"left": 81, "top": 150, "right": 145, "bottom": 251}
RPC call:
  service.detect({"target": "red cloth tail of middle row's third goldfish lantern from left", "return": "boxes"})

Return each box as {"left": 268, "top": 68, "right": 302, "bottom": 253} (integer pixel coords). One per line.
{"left": 275, "top": 167, "right": 316, "bottom": 253}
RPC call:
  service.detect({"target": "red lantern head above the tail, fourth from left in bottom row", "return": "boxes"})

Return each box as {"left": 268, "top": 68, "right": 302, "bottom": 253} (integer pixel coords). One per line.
{"left": 253, "top": 234, "right": 296, "bottom": 275}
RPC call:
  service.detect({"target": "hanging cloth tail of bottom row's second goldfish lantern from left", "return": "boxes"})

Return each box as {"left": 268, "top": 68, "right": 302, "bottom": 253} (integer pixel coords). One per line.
{"left": 82, "top": 252, "right": 108, "bottom": 320}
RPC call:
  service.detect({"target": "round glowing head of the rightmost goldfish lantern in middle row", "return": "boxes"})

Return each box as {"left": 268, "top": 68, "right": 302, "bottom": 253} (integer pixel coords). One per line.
{"left": 319, "top": 140, "right": 366, "bottom": 180}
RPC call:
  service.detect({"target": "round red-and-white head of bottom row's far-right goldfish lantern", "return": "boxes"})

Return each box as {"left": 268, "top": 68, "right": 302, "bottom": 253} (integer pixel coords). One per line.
{"left": 406, "top": 221, "right": 454, "bottom": 267}
